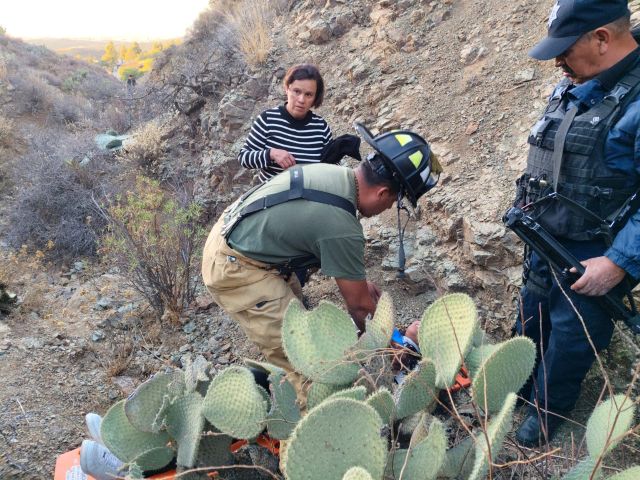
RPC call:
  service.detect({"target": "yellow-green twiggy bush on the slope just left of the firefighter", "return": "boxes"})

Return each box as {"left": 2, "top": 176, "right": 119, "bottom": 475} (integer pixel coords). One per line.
{"left": 100, "top": 176, "right": 205, "bottom": 321}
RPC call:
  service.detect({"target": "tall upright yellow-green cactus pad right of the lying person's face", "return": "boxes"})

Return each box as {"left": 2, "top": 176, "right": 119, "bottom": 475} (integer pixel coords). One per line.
{"left": 418, "top": 293, "right": 478, "bottom": 388}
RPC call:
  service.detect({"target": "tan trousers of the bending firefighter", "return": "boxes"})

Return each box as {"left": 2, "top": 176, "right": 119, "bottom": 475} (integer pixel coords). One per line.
{"left": 202, "top": 216, "right": 305, "bottom": 403}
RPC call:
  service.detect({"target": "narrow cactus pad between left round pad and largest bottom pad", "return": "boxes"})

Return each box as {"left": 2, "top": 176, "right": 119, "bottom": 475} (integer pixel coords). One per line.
{"left": 267, "top": 371, "right": 301, "bottom": 440}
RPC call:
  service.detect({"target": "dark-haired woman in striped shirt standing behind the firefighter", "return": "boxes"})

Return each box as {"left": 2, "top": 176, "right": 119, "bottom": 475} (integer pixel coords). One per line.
{"left": 238, "top": 64, "right": 331, "bottom": 182}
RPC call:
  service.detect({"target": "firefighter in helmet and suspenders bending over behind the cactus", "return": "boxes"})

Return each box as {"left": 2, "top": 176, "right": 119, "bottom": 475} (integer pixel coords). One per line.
{"left": 202, "top": 125, "right": 441, "bottom": 392}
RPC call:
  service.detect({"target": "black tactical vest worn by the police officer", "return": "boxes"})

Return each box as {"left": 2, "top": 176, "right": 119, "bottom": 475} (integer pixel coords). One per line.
{"left": 525, "top": 66, "right": 640, "bottom": 241}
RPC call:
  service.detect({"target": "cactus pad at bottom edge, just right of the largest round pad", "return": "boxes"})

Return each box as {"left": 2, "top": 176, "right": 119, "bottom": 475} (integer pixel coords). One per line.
{"left": 389, "top": 419, "right": 447, "bottom": 480}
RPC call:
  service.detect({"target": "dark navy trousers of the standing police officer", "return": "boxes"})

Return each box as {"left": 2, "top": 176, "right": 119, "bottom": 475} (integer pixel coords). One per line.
{"left": 516, "top": 242, "right": 613, "bottom": 413}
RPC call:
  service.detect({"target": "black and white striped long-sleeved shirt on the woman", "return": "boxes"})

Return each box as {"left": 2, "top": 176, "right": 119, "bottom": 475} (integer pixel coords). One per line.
{"left": 238, "top": 106, "right": 331, "bottom": 182}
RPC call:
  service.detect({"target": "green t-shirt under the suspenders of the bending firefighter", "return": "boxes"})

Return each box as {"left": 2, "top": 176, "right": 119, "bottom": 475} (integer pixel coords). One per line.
{"left": 228, "top": 164, "right": 365, "bottom": 280}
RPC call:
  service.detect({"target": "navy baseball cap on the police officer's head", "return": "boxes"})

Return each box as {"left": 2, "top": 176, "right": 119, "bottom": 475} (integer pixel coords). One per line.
{"left": 529, "top": 0, "right": 631, "bottom": 60}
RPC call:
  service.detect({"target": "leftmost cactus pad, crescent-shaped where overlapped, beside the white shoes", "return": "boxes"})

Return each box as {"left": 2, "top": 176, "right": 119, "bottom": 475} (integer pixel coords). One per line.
{"left": 100, "top": 400, "right": 170, "bottom": 463}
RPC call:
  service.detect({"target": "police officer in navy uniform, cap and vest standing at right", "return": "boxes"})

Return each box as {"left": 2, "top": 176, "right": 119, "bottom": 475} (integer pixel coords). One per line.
{"left": 516, "top": 0, "right": 640, "bottom": 446}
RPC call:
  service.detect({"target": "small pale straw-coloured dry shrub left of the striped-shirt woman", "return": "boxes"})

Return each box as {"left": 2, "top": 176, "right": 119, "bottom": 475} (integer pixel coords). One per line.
{"left": 121, "top": 121, "right": 167, "bottom": 175}
